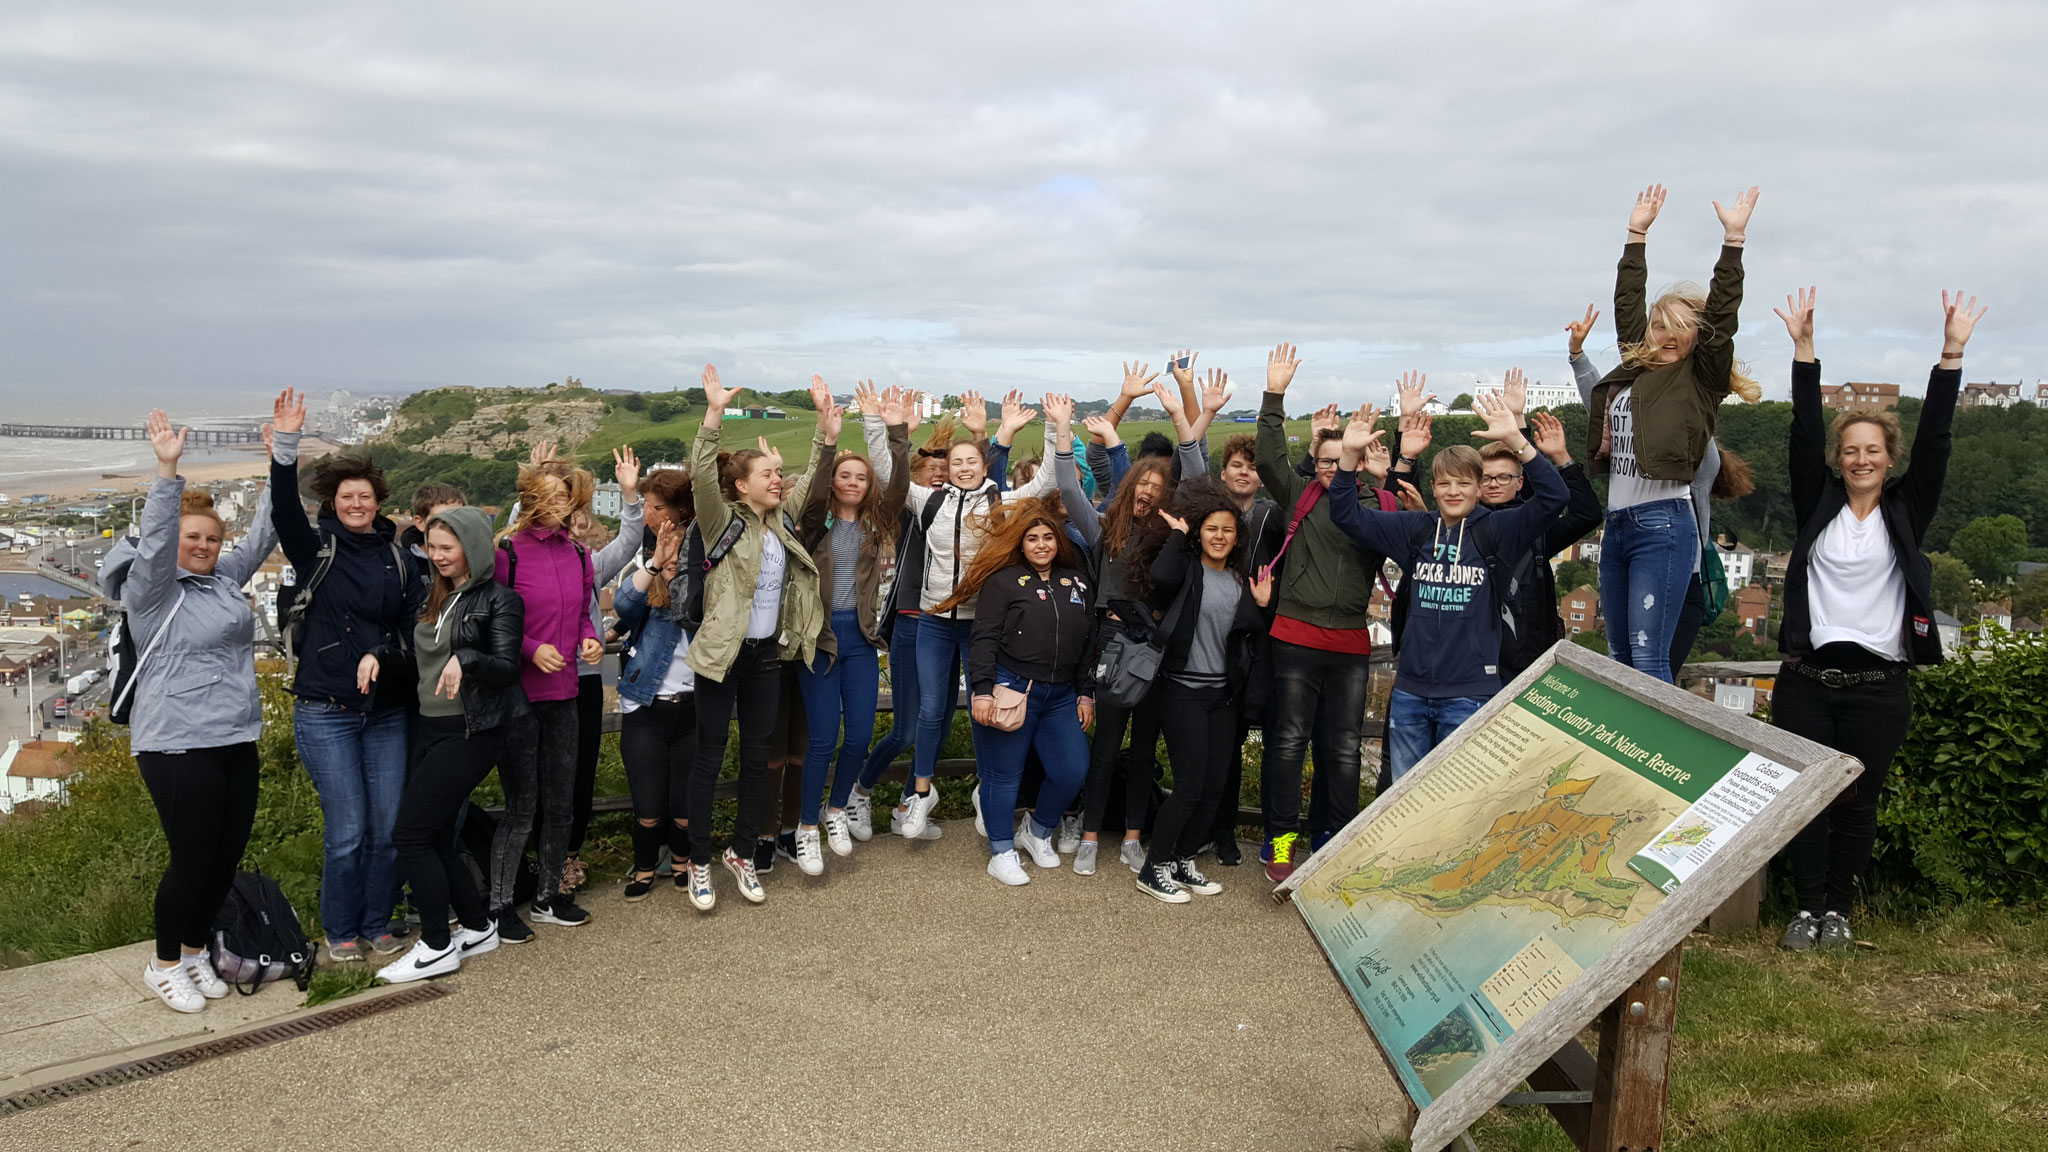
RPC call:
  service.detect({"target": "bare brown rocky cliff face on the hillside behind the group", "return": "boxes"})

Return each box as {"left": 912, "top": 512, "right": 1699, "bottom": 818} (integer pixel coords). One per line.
{"left": 383, "top": 387, "right": 604, "bottom": 459}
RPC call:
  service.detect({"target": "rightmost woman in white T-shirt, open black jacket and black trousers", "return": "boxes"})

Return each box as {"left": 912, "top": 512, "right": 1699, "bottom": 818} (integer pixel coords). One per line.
{"left": 1772, "top": 289, "right": 1985, "bottom": 951}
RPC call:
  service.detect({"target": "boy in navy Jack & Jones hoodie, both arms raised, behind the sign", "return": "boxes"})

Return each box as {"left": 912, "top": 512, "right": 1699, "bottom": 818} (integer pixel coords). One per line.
{"left": 1329, "top": 394, "right": 1569, "bottom": 779}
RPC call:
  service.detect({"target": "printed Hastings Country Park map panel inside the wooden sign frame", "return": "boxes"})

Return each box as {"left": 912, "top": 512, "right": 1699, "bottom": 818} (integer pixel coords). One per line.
{"left": 1294, "top": 664, "right": 1794, "bottom": 1107}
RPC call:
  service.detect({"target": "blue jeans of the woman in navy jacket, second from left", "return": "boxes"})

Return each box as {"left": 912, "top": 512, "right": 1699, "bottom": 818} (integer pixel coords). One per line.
{"left": 291, "top": 699, "right": 406, "bottom": 941}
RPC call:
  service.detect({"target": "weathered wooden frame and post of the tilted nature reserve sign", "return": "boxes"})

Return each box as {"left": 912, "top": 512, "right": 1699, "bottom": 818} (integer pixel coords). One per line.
{"left": 1272, "top": 640, "right": 1864, "bottom": 1152}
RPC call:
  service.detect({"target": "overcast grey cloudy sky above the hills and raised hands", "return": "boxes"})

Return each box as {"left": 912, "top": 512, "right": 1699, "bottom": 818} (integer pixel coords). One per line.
{"left": 0, "top": 0, "right": 2048, "bottom": 416}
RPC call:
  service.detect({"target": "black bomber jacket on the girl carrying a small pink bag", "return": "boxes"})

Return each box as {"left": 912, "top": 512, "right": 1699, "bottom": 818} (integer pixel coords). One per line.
{"left": 967, "top": 564, "right": 1096, "bottom": 697}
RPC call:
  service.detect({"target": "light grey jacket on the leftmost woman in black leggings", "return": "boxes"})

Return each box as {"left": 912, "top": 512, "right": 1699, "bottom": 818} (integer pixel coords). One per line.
{"left": 100, "top": 476, "right": 276, "bottom": 752}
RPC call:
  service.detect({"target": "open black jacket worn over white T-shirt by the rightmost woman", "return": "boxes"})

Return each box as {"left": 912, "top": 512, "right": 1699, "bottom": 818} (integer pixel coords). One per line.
{"left": 1778, "top": 361, "right": 1962, "bottom": 664}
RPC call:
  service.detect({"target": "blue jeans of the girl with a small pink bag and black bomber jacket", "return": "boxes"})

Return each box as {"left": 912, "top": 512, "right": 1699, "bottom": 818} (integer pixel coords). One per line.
{"left": 975, "top": 672, "right": 1087, "bottom": 857}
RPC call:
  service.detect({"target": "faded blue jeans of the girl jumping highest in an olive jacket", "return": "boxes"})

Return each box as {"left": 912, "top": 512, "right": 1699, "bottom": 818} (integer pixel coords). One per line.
{"left": 1599, "top": 498, "right": 1700, "bottom": 685}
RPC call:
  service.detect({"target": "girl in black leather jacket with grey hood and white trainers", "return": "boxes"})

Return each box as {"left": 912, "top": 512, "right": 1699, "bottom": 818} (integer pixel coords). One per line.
{"left": 381, "top": 508, "right": 526, "bottom": 982}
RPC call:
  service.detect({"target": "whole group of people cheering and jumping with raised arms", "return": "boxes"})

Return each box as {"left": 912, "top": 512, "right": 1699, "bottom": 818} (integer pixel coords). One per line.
{"left": 102, "top": 187, "right": 1982, "bottom": 1011}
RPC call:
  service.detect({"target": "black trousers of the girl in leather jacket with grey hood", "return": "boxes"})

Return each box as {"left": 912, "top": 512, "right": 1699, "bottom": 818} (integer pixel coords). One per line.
{"left": 391, "top": 715, "right": 506, "bottom": 951}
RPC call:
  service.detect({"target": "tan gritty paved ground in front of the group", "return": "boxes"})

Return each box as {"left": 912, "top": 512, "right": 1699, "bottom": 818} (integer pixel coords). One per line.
{"left": 0, "top": 822, "right": 1407, "bottom": 1152}
